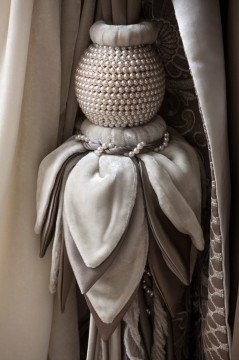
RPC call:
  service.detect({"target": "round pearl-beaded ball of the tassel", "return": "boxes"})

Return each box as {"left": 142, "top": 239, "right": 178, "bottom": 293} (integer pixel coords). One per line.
{"left": 75, "top": 44, "right": 165, "bottom": 127}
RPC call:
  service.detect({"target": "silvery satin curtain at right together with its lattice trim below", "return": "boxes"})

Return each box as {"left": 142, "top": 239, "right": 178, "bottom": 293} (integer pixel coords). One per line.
{"left": 172, "top": 0, "right": 231, "bottom": 359}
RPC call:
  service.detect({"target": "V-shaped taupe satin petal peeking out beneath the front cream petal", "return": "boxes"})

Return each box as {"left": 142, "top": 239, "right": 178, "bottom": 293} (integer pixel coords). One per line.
{"left": 64, "top": 220, "right": 125, "bottom": 294}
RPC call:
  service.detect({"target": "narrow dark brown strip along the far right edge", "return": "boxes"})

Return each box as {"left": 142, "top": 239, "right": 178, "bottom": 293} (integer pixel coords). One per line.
{"left": 226, "top": 0, "right": 239, "bottom": 360}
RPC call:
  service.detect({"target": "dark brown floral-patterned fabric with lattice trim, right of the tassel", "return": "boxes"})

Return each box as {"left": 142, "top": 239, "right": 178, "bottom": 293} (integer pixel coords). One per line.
{"left": 143, "top": 0, "right": 229, "bottom": 360}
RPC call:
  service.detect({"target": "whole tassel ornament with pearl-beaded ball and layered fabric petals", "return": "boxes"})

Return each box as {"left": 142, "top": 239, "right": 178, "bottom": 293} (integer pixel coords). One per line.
{"left": 35, "top": 22, "right": 204, "bottom": 339}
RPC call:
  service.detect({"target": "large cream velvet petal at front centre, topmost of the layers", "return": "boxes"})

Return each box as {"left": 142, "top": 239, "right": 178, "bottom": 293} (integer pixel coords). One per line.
{"left": 64, "top": 153, "right": 137, "bottom": 268}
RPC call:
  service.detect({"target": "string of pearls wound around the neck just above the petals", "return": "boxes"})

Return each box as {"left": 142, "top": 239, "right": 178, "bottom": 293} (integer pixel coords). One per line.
{"left": 75, "top": 132, "right": 170, "bottom": 158}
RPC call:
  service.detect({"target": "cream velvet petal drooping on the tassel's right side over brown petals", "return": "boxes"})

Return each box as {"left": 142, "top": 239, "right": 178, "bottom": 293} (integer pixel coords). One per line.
{"left": 139, "top": 137, "right": 204, "bottom": 250}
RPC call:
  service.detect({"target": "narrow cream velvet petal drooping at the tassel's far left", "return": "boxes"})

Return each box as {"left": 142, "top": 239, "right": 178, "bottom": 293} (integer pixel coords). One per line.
{"left": 35, "top": 139, "right": 85, "bottom": 234}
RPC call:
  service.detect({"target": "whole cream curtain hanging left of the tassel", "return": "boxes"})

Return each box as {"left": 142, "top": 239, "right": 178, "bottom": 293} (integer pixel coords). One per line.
{"left": 0, "top": 0, "right": 79, "bottom": 360}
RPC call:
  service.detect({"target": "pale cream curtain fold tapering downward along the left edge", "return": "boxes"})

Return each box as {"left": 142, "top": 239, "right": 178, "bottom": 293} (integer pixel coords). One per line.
{"left": 0, "top": 0, "right": 34, "bottom": 214}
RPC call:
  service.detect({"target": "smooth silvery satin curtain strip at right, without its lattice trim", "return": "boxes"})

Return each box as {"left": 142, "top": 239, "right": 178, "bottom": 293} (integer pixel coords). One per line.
{"left": 172, "top": 0, "right": 231, "bottom": 352}
